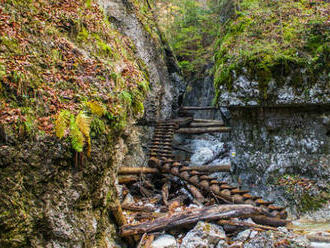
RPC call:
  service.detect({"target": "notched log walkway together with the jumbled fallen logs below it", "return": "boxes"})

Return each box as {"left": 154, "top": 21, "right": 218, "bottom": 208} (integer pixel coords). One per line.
{"left": 115, "top": 113, "right": 288, "bottom": 246}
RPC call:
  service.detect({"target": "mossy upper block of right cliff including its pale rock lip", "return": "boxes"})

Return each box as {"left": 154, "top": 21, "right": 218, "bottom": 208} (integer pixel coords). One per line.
{"left": 215, "top": 0, "right": 330, "bottom": 105}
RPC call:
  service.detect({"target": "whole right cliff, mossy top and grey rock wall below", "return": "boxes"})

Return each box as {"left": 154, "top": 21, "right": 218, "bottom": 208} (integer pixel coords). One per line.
{"left": 215, "top": 1, "right": 330, "bottom": 213}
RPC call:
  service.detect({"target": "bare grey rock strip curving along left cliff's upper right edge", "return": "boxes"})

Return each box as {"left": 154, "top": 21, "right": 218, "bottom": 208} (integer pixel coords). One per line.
{"left": 99, "top": 0, "right": 185, "bottom": 121}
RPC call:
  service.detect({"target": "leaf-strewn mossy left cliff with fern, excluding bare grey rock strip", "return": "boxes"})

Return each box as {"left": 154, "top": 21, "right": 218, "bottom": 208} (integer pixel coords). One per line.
{"left": 0, "top": 0, "right": 149, "bottom": 247}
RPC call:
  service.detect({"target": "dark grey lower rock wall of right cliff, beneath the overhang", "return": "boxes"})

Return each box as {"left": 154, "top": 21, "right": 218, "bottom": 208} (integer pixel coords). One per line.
{"left": 229, "top": 106, "right": 330, "bottom": 215}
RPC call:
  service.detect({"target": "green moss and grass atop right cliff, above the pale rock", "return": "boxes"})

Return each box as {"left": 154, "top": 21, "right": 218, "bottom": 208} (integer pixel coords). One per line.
{"left": 214, "top": 0, "right": 330, "bottom": 100}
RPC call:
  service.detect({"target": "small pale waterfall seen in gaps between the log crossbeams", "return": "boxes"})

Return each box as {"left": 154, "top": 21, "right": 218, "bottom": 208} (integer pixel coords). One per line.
{"left": 174, "top": 68, "right": 233, "bottom": 183}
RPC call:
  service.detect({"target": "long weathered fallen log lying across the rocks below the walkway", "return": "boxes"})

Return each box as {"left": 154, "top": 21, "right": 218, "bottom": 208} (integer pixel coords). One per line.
{"left": 121, "top": 205, "right": 262, "bottom": 237}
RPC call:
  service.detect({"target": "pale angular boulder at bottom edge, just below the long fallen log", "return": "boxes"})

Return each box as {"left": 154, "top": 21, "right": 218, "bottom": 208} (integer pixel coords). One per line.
{"left": 180, "top": 221, "right": 226, "bottom": 248}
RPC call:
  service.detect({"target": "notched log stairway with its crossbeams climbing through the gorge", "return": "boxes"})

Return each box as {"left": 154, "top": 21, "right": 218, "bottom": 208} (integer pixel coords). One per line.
{"left": 119, "top": 107, "right": 288, "bottom": 236}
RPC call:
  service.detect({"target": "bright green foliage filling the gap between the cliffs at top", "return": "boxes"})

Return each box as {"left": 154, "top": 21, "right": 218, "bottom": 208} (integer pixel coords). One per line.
{"left": 156, "top": 0, "right": 219, "bottom": 78}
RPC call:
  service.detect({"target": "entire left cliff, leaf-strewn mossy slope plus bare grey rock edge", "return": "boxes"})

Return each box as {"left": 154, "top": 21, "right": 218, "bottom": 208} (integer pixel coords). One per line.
{"left": 0, "top": 0, "right": 183, "bottom": 247}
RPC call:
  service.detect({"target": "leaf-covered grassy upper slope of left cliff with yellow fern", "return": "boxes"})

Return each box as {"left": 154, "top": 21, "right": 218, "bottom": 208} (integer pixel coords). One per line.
{"left": 0, "top": 0, "right": 149, "bottom": 153}
